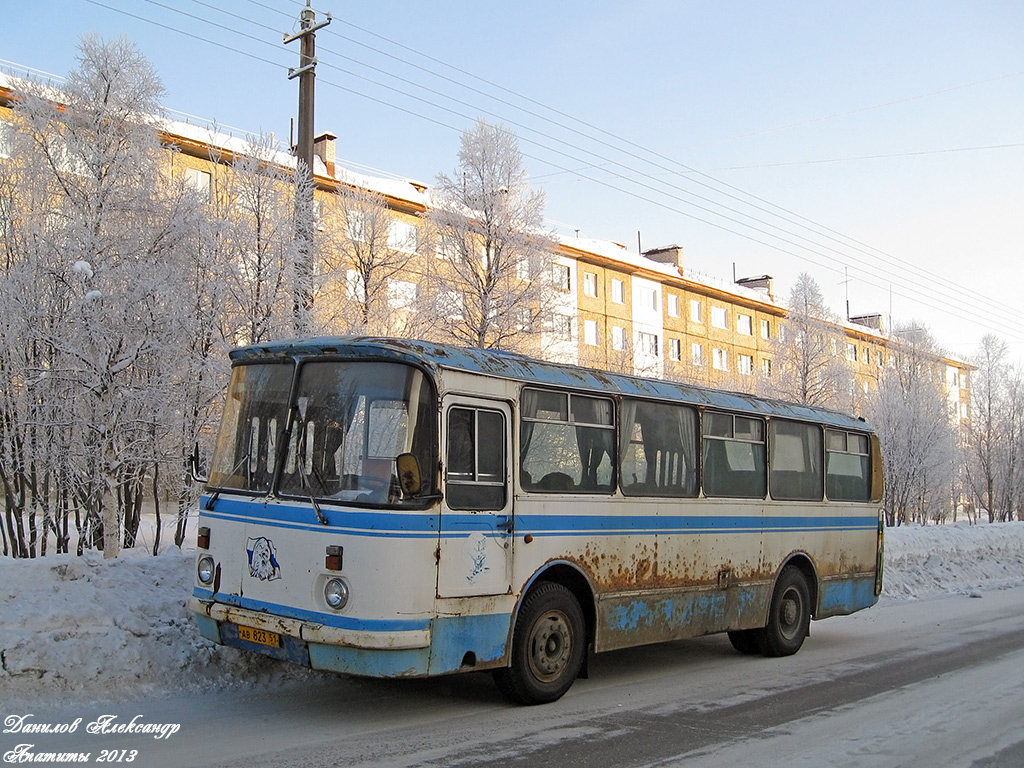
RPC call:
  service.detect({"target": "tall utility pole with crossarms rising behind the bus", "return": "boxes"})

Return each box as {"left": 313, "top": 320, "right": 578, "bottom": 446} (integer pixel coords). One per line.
{"left": 285, "top": 0, "right": 331, "bottom": 335}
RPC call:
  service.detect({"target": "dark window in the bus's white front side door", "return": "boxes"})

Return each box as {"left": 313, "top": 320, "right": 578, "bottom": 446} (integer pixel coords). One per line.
{"left": 445, "top": 408, "right": 508, "bottom": 510}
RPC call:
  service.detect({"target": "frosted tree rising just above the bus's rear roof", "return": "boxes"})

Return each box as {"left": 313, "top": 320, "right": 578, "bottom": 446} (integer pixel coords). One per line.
{"left": 768, "top": 272, "right": 853, "bottom": 408}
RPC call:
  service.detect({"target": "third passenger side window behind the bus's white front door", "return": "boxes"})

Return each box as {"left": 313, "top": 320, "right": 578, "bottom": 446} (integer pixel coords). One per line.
{"left": 703, "top": 411, "right": 768, "bottom": 499}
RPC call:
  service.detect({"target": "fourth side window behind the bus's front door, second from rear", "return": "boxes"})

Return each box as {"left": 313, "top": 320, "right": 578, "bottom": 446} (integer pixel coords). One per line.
{"left": 768, "top": 419, "right": 824, "bottom": 502}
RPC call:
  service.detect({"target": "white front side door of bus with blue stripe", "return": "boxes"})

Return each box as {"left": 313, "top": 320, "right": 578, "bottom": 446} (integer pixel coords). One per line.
{"left": 437, "top": 397, "right": 515, "bottom": 597}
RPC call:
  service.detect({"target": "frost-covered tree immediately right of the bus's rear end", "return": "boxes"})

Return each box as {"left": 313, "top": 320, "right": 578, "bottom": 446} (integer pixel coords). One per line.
{"left": 869, "top": 324, "right": 959, "bottom": 525}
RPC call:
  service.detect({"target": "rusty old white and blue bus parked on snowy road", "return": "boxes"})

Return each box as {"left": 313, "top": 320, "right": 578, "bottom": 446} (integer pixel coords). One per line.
{"left": 189, "top": 337, "right": 883, "bottom": 703}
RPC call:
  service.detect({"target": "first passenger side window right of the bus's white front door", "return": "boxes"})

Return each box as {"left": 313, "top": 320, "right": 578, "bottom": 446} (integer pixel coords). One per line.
{"left": 519, "top": 389, "right": 615, "bottom": 494}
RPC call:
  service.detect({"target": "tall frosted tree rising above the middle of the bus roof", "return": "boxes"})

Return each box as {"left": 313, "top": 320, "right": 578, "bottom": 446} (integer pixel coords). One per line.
{"left": 418, "top": 120, "right": 554, "bottom": 348}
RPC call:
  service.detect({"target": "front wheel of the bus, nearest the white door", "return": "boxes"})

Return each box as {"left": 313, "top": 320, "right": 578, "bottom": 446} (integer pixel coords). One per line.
{"left": 495, "top": 582, "right": 587, "bottom": 705}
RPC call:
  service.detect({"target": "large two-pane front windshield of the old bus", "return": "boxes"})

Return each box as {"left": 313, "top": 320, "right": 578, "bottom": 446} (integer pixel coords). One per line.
{"left": 209, "top": 360, "right": 437, "bottom": 506}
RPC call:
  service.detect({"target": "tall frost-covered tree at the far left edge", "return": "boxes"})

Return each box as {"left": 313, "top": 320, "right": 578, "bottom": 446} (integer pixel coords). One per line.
{"left": 0, "top": 37, "right": 203, "bottom": 556}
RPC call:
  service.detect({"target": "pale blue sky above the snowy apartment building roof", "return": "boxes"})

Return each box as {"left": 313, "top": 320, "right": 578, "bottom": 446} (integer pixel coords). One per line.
{"left": 0, "top": 0, "right": 1024, "bottom": 360}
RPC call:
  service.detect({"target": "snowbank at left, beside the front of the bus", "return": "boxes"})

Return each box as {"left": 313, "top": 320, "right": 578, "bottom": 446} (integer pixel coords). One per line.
{"left": 0, "top": 549, "right": 327, "bottom": 702}
